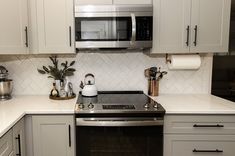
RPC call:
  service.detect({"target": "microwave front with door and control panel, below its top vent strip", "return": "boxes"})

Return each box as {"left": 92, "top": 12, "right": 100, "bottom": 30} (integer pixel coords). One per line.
{"left": 75, "top": 13, "right": 153, "bottom": 49}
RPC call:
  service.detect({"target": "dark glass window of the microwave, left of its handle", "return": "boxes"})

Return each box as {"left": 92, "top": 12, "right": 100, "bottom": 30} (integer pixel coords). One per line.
{"left": 75, "top": 17, "right": 132, "bottom": 41}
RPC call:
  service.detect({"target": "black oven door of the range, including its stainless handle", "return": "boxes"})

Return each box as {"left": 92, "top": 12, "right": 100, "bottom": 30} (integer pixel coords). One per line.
{"left": 76, "top": 118, "right": 163, "bottom": 156}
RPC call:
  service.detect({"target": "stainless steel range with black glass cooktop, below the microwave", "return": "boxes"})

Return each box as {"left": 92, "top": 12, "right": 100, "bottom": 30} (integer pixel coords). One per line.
{"left": 75, "top": 91, "right": 165, "bottom": 156}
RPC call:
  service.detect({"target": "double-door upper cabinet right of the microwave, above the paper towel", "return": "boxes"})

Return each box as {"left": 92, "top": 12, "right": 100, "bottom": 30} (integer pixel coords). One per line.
{"left": 152, "top": 0, "right": 231, "bottom": 53}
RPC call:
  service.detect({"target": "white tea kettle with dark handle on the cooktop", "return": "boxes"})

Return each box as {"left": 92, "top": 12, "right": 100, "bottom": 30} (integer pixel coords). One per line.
{"left": 80, "top": 73, "right": 98, "bottom": 97}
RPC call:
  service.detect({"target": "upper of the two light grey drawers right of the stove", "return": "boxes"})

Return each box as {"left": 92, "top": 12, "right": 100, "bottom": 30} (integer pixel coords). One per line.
{"left": 164, "top": 115, "right": 235, "bottom": 134}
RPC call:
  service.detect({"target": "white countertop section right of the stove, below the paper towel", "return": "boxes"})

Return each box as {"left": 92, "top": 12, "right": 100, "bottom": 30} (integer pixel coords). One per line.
{"left": 152, "top": 94, "right": 235, "bottom": 115}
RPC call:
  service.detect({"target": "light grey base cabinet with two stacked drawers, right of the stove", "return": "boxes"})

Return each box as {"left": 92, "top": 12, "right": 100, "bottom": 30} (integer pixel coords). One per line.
{"left": 164, "top": 115, "right": 235, "bottom": 156}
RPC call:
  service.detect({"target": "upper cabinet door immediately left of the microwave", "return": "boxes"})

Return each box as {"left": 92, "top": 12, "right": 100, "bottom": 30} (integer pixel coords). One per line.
{"left": 36, "top": 0, "right": 75, "bottom": 53}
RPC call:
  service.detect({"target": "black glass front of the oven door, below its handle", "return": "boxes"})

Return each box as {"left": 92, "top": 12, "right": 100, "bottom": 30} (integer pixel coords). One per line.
{"left": 76, "top": 126, "right": 163, "bottom": 156}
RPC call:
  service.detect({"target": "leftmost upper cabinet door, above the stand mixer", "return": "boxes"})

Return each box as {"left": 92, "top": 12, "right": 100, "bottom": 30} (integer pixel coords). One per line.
{"left": 0, "top": 0, "right": 28, "bottom": 54}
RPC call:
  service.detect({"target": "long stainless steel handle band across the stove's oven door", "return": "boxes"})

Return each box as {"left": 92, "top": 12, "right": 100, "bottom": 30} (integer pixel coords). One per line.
{"left": 76, "top": 118, "right": 163, "bottom": 127}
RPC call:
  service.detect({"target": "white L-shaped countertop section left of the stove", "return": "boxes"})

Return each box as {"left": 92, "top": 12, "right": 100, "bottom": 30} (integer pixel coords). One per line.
{"left": 0, "top": 96, "right": 77, "bottom": 137}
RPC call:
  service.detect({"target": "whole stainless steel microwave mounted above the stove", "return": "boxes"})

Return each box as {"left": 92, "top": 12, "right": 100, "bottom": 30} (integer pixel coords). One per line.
{"left": 75, "top": 5, "right": 153, "bottom": 49}
